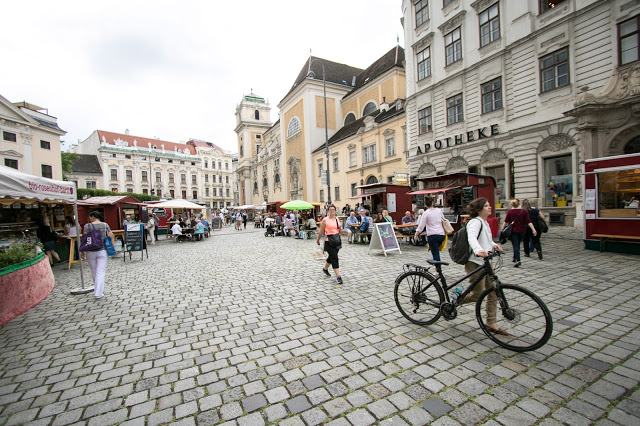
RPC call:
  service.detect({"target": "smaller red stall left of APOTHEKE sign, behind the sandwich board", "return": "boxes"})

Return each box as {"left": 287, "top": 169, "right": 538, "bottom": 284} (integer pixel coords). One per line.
{"left": 350, "top": 182, "right": 413, "bottom": 224}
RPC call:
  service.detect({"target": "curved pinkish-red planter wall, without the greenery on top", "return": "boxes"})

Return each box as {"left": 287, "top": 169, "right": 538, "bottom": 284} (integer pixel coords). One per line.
{"left": 0, "top": 253, "right": 55, "bottom": 326}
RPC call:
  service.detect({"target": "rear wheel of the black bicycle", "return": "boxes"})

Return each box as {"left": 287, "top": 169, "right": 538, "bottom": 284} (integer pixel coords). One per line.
{"left": 393, "top": 271, "right": 444, "bottom": 325}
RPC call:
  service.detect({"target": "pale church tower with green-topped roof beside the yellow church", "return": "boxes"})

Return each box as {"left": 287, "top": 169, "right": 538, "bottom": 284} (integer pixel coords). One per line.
{"left": 235, "top": 93, "right": 271, "bottom": 205}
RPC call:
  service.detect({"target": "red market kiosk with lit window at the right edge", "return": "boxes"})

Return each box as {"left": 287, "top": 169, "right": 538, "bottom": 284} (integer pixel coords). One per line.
{"left": 583, "top": 154, "right": 640, "bottom": 254}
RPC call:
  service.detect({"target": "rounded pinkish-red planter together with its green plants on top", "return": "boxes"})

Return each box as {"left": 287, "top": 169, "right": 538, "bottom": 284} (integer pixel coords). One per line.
{"left": 0, "top": 242, "right": 55, "bottom": 325}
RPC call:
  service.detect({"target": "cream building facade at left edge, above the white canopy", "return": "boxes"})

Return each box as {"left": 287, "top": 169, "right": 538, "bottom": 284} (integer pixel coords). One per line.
{"left": 0, "top": 96, "right": 66, "bottom": 180}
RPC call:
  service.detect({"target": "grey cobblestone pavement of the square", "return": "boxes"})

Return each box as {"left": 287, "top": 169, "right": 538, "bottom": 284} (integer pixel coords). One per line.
{"left": 0, "top": 224, "right": 640, "bottom": 426}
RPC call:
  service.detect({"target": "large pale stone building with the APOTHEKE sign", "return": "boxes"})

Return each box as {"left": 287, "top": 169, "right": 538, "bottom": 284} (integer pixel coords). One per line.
{"left": 402, "top": 0, "right": 640, "bottom": 227}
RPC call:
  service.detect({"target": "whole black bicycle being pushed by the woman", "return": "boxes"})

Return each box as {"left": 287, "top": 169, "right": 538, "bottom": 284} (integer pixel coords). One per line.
{"left": 394, "top": 251, "right": 553, "bottom": 352}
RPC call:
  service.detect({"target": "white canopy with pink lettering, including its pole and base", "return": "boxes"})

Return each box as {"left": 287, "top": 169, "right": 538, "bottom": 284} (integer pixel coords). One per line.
{"left": 0, "top": 166, "right": 92, "bottom": 294}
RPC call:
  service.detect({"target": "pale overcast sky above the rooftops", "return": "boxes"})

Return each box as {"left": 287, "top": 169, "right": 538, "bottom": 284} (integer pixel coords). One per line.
{"left": 0, "top": 0, "right": 404, "bottom": 152}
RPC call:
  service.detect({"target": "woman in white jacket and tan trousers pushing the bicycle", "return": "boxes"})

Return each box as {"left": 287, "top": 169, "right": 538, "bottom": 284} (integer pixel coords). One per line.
{"left": 464, "top": 198, "right": 509, "bottom": 336}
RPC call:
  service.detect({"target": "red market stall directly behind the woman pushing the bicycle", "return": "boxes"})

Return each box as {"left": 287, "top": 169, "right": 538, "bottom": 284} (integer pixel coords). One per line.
{"left": 410, "top": 173, "right": 499, "bottom": 238}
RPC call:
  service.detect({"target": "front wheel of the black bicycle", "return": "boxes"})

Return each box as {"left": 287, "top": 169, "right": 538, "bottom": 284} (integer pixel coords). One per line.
{"left": 476, "top": 284, "right": 553, "bottom": 352}
